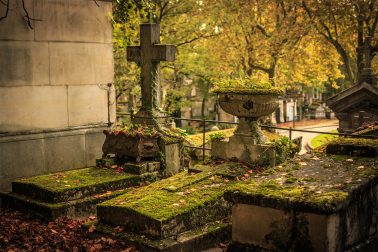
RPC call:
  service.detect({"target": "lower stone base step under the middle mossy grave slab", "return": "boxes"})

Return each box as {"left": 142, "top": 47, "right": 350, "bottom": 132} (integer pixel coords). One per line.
{"left": 85, "top": 219, "right": 231, "bottom": 252}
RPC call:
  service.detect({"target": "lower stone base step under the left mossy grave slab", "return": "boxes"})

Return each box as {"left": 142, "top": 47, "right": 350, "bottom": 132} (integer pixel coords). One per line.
{"left": 0, "top": 190, "right": 125, "bottom": 219}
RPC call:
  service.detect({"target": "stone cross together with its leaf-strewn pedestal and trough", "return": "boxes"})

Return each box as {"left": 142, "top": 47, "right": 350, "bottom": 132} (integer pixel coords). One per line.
{"left": 102, "top": 24, "right": 183, "bottom": 175}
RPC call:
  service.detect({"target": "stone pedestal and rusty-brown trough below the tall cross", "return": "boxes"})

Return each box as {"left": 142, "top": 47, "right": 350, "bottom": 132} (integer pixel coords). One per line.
{"left": 97, "top": 132, "right": 184, "bottom": 176}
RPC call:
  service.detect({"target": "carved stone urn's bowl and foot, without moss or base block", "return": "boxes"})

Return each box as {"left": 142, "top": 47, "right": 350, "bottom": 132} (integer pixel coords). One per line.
{"left": 219, "top": 92, "right": 278, "bottom": 144}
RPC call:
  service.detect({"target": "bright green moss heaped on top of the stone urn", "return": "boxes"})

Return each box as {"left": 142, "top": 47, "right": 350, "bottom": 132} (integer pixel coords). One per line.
{"left": 212, "top": 78, "right": 284, "bottom": 95}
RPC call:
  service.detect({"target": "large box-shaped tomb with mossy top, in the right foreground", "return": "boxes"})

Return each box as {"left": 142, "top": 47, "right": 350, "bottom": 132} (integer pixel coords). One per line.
{"left": 225, "top": 153, "right": 378, "bottom": 251}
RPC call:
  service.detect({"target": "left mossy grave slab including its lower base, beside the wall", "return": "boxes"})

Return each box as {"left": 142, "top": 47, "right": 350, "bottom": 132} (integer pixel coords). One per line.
{"left": 0, "top": 167, "right": 156, "bottom": 218}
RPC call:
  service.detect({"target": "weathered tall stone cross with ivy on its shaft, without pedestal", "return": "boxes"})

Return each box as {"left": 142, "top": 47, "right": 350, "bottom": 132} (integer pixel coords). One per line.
{"left": 127, "top": 24, "right": 176, "bottom": 125}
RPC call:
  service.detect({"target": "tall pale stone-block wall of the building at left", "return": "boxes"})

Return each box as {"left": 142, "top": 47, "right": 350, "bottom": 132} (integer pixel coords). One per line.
{"left": 0, "top": 0, "right": 115, "bottom": 188}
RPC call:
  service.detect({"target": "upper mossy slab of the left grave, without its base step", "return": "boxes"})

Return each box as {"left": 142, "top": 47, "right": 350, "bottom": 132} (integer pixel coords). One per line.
{"left": 12, "top": 167, "right": 148, "bottom": 203}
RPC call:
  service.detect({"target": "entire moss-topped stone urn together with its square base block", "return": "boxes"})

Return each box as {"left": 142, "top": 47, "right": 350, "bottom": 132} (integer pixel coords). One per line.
{"left": 212, "top": 78, "right": 283, "bottom": 164}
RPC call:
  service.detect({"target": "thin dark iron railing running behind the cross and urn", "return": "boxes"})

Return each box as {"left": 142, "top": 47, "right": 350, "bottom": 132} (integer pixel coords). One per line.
{"left": 117, "top": 113, "right": 378, "bottom": 160}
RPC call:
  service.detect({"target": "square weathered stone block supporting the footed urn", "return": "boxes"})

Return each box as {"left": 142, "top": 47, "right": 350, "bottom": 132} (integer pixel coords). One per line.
{"left": 211, "top": 134, "right": 275, "bottom": 166}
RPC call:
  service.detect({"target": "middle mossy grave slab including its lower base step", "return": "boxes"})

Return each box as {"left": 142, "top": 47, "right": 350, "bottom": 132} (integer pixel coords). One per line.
{"left": 95, "top": 161, "right": 251, "bottom": 251}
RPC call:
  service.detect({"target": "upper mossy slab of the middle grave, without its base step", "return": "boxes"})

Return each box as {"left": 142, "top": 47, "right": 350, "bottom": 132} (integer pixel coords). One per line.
{"left": 97, "top": 171, "right": 234, "bottom": 239}
